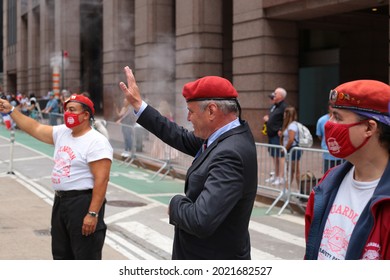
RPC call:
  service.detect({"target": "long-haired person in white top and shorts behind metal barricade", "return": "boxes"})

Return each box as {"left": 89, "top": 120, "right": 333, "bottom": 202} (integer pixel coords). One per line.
{"left": 280, "top": 106, "right": 302, "bottom": 187}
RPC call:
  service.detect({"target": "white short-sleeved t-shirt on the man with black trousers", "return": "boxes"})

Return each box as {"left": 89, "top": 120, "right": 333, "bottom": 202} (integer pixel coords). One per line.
{"left": 51, "top": 125, "right": 113, "bottom": 191}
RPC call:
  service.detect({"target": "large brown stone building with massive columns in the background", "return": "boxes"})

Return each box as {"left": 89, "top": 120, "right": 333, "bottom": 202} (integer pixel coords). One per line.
{"left": 3, "top": 0, "right": 390, "bottom": 141}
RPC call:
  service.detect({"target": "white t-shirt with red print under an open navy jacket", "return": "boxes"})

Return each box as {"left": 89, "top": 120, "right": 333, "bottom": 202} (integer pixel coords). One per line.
{"left": 318, "top": 167, "right": 380, "bottom": 260}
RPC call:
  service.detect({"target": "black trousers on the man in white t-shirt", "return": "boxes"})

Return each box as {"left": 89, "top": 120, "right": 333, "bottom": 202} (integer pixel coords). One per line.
{"left": 51, "top": 191, "right": 107, "bottom": 260}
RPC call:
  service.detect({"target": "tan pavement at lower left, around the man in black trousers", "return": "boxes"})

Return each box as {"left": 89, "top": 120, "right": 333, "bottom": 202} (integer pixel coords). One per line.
{"left": 0, "top": 175, "right": 127, "bottom": 260}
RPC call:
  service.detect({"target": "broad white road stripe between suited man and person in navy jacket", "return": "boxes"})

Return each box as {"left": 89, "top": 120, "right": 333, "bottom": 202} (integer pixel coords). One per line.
{"left": 249, "top": 221, "right": 306, "bottom": 248}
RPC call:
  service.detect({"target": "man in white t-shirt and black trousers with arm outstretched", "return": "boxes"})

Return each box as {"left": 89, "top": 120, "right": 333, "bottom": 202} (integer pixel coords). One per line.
{"left": 0, "top": 94, "right": 113, "bottom": 260}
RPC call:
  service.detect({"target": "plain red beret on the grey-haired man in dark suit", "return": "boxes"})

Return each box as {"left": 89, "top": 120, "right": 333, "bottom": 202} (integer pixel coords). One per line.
{"left": 183, "top": 76, "right": 238, "bottom": 102}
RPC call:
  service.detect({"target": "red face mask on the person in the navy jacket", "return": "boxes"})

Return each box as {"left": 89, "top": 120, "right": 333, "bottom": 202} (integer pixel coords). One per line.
{"left": 325, "top": 121, "right": 370, "bottom": 158}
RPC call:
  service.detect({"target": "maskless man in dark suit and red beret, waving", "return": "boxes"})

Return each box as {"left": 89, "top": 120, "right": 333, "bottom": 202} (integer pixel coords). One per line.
{"left": 120, "top": 67, "right": 257, "bottom": 259}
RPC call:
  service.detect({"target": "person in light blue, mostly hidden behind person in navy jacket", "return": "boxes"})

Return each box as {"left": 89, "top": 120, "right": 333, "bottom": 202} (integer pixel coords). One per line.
{"left": 316, "top": 105, "right": 343, "bottom": 174}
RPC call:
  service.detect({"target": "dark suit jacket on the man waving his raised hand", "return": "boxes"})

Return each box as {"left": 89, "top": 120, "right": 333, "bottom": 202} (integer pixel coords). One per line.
{"left": 138, "top": 106, "right": 257, "bottom": 259}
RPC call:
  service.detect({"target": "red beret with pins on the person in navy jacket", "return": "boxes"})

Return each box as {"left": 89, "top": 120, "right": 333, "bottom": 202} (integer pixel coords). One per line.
{"left": 329, "top": 80, "right": 390, "bottom": 125}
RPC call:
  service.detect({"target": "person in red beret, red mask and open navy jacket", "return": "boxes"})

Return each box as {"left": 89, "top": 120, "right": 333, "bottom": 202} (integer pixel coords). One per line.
{"left": 305, "top": 80, "right": 390, "bottom": 260}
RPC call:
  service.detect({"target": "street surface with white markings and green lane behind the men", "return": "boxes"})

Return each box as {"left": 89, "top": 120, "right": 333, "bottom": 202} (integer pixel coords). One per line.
{"left": 0, "top": 126, "right": 304, "bottom": 260}
